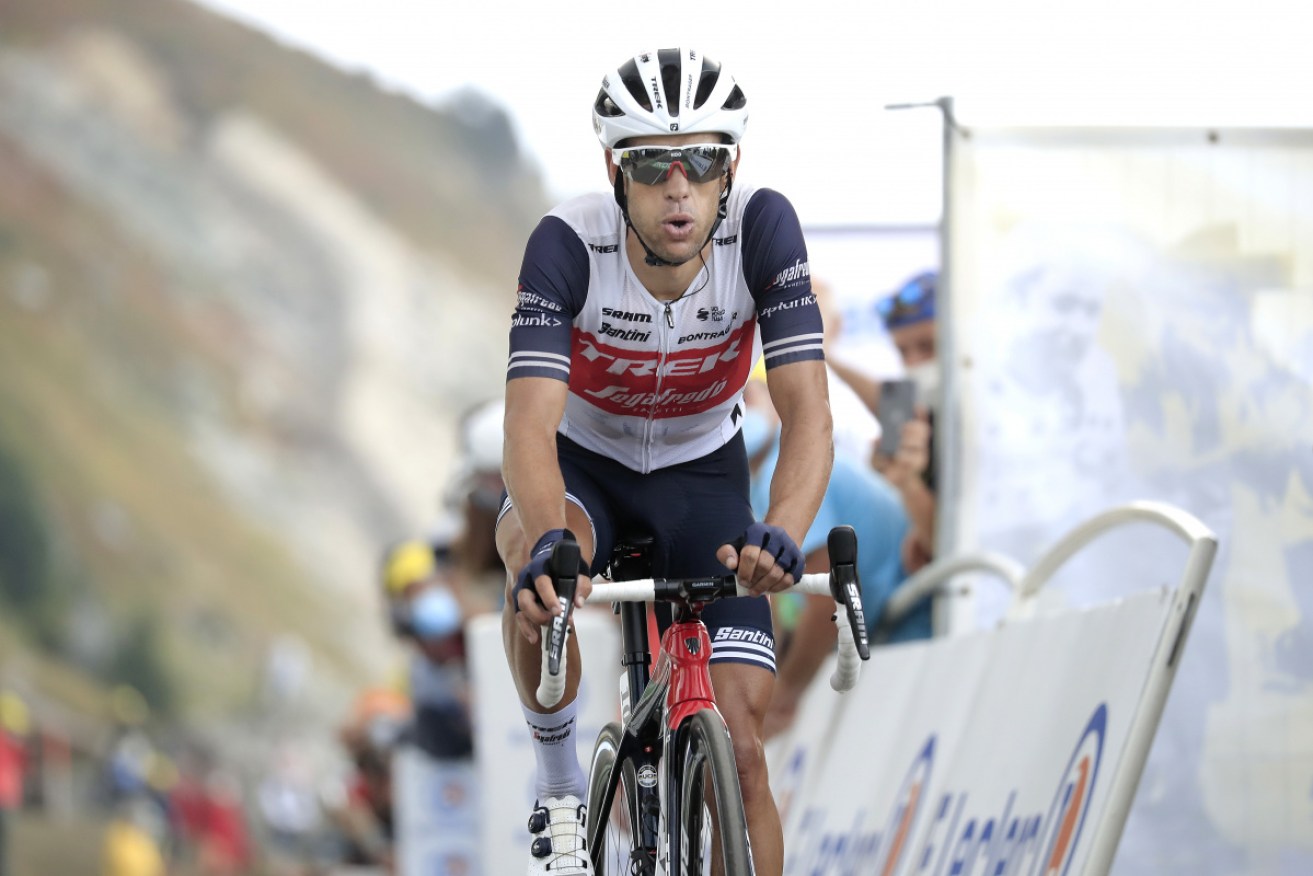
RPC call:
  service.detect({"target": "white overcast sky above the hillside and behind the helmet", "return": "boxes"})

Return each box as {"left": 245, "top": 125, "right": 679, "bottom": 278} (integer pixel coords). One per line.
{"left": 190, "top": 0, "right": 1313, "bottom": 225}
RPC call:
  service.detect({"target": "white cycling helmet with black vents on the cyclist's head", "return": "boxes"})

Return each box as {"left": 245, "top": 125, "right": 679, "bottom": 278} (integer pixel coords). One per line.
{"left": 592, "top": 49, "right": 747, "bottom": 148}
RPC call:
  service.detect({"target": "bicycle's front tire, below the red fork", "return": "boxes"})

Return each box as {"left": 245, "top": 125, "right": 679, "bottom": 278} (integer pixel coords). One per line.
{"left": 671, "top": 709, "right": 755, "bottom": 876}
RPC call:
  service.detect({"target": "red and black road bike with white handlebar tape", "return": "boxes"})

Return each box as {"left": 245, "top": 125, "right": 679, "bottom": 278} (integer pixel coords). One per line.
{"left": 538, "top": 527, "right": 869, "bottom": 876}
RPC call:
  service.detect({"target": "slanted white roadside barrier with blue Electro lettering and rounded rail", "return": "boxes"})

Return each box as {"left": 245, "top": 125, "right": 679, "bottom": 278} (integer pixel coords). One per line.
{"left": 768, "top": 503, "right": 1216, "bottom": 876}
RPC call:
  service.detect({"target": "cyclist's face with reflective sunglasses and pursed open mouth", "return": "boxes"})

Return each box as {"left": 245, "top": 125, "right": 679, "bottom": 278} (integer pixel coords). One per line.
{"left": 607, "top": 134, "right": 738, "bottom": 263}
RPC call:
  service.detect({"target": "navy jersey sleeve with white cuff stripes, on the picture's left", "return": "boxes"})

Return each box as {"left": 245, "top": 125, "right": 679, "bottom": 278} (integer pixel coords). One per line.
{"left": 506, "top": 215, "right": 588, "bottom": 381}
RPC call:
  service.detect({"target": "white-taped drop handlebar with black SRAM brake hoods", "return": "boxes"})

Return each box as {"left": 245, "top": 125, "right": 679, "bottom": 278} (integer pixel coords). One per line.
{"left": 537, "top": 527, "right": 871, "bottom": 708}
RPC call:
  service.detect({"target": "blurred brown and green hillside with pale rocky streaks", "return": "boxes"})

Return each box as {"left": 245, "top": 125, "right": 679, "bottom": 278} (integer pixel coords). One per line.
{"left": 0, "top": 0, "right": 544, "bottom": 756}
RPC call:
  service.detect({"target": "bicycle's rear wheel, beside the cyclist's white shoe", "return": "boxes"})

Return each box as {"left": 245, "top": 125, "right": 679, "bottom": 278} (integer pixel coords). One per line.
{"left": 587, "top": 721, "right": 655, "bottom": 876}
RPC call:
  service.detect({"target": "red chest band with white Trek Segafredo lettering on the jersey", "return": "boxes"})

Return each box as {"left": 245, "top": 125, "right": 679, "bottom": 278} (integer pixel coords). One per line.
{"left": 570, "top": 319, "right": 756, "bottom": 418}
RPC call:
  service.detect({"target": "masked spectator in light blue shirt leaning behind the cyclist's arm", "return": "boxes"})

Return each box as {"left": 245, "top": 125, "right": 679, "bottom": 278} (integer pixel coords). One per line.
{"left": 743, "top": 380, "right": 931, "bottom": 737}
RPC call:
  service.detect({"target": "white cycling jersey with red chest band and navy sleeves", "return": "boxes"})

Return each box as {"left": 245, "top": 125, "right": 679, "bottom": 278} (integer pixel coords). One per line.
{"left": 507, "top": 185, "right": 823, "bottom": 473}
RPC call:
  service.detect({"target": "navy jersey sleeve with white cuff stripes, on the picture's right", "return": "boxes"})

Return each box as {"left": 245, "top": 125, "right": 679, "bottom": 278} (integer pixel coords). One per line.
{"left": 742, "top": 189, "right": 825, "bottom": 369}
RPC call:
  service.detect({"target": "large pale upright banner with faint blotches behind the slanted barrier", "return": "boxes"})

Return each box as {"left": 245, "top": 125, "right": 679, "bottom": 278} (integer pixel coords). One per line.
{"left": 941, "top": 129, "right": 1313, "bottom": 876}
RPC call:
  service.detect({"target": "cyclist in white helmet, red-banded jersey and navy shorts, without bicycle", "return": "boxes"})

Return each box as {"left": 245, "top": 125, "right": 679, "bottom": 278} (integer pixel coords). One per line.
{"left": 498, "top": 49, "right": 834, "bottom": 876}
